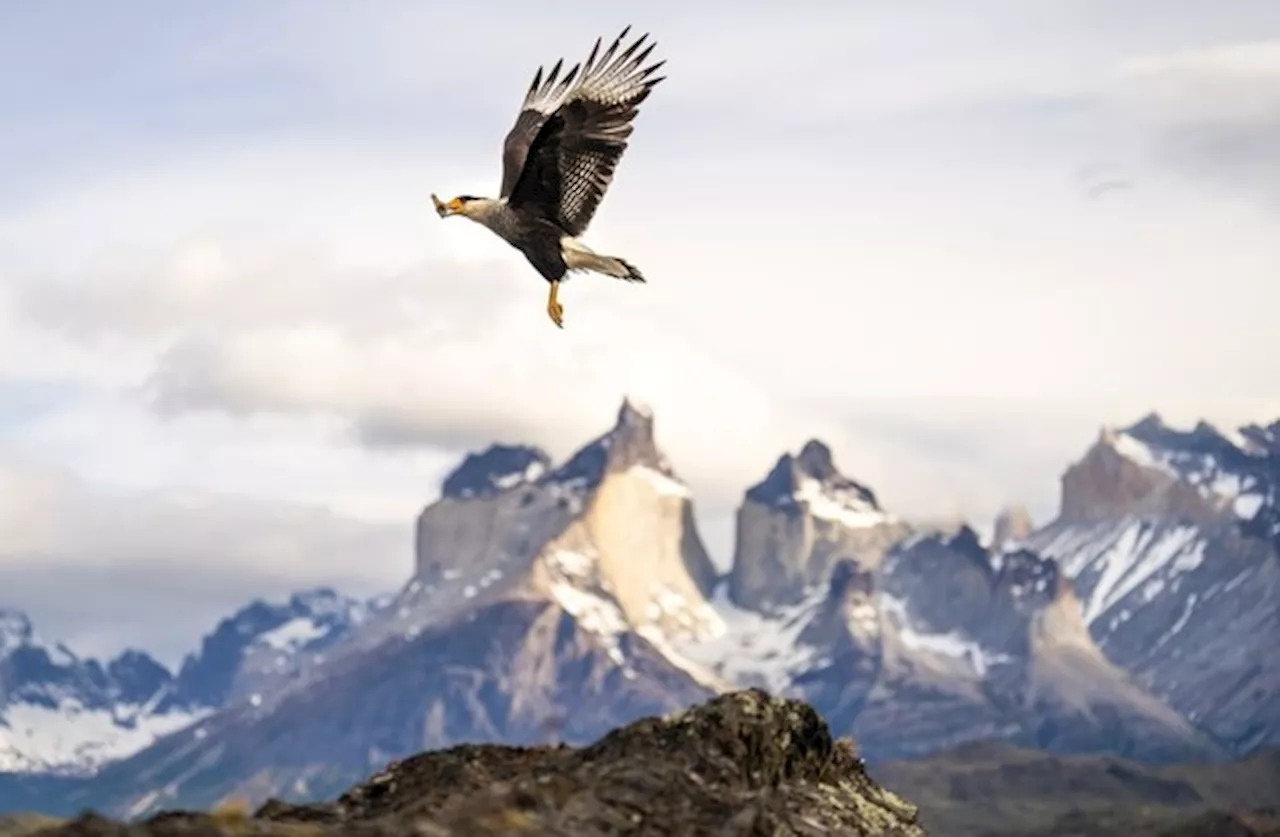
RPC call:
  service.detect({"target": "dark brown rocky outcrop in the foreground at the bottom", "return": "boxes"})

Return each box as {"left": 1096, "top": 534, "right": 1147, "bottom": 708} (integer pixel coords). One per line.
{"left": 36, "top": 690, "right": 924, "bottom": 837}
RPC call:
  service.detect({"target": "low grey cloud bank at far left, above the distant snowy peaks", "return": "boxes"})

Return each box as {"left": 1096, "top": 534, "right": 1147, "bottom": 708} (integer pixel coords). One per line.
{"left": 0, "top": 452, "right": 411, "bottom": 663}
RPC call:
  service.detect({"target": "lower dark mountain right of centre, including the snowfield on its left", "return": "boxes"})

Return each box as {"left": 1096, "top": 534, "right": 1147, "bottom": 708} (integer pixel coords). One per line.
{"left": 676, "top": 527, "right": 1221, "bottom": 760}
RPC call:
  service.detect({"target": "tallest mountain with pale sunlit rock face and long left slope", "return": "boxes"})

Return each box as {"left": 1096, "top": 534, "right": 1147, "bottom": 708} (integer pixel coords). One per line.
{"left": 40, "top": 403, "right": 716, "bottom": 814}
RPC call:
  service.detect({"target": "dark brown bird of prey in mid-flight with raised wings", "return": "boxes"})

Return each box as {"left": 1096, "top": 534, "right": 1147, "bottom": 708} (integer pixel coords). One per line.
{"left": 431, "top": 26, "right": 666, "bottom": 328}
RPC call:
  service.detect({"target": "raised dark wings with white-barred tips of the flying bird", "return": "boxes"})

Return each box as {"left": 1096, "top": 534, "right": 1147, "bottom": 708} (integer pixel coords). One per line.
{"left": 500, "top": 27, "right": 666, "bottom": 235}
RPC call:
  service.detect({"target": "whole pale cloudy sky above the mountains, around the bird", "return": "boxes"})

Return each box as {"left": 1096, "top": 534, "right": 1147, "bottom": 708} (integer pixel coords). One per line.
{"left": 0, "top": 0, "right": 1280, "bottom": 664}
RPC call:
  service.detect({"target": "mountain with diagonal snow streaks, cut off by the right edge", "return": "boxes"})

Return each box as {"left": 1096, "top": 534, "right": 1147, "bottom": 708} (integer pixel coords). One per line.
{"left": 1024, "top": 415, "right": 1280, "bottom": 753}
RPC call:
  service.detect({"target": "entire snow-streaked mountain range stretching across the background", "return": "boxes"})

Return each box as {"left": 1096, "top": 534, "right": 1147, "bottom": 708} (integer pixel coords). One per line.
{"left": 0, "top": 402, "right": 1280, "bottom": 817}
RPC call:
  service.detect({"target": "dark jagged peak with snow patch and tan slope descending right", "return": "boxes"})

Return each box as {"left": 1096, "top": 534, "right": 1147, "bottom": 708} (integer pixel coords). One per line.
{"left": 851, "top": 527, "right": 1221, "bottom": 760}
